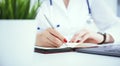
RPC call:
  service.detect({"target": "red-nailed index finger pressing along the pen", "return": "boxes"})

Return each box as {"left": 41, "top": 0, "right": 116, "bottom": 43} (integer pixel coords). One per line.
{"left": 48, "top": 28, "right": 67, "bottom": 43}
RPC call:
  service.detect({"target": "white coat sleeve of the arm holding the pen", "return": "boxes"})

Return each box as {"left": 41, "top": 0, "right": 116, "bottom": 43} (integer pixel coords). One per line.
{"left": 36, "top": 1, "right": 50, "bottom": 32}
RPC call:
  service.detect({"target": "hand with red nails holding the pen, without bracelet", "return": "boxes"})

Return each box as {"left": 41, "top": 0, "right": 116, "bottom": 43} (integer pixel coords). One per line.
{"left": 36, "top": 28, "right": 67, "bottom": 48}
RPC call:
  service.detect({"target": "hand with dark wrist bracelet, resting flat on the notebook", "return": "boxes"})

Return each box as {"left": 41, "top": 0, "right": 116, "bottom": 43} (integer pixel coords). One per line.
{"left": 70, "top": 29, "right": 114, "bottom": 44}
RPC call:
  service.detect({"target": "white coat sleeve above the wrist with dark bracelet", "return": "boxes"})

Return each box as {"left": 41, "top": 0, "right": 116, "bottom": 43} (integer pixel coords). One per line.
{"left": 90, "top": 0, "right": 120, "bottom": 43}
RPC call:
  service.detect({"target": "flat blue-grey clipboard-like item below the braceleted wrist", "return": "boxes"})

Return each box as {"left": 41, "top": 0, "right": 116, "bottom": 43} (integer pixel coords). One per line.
{"left": 76, "top": 44, "right": 120, "bottom": 57}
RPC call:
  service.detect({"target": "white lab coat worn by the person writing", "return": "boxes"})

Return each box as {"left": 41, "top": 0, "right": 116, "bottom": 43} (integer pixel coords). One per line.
{"left": 36, "top": 0, "right": 120, "bottom": 42}
